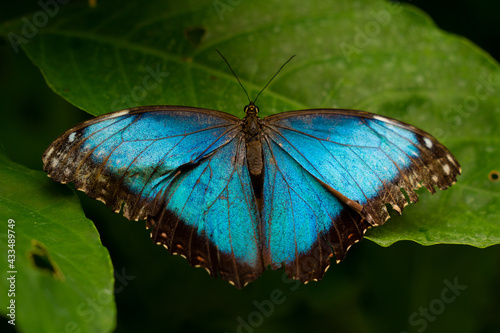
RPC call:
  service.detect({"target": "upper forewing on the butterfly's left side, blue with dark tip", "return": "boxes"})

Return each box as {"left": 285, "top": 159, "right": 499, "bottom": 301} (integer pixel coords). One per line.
{"left": 43, "top": 106, "right": 239, "bottom": 219}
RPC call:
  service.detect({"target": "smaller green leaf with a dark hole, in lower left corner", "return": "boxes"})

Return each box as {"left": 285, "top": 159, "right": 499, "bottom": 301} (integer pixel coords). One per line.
{"left": 0, "top": 152, "right": 116, "bottom": 332}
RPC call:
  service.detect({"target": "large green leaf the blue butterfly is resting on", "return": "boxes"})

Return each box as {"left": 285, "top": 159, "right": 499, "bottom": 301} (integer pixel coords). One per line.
{"left": 2, "top": 0, "right": 500, "bottom": 247}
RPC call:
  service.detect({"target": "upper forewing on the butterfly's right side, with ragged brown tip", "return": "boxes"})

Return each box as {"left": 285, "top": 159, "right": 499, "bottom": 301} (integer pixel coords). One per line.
{"left": 264, "top": 109, "right": 460, "bottom": 225}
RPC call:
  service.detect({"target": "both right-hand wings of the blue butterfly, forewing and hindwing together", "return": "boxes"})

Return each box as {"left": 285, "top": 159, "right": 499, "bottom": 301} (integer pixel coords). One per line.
{"left": 262, "top": 109, "right": 460, "bottom": 281}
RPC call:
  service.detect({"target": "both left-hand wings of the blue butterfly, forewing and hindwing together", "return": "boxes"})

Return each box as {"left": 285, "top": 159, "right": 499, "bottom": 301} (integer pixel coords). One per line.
{"left": 43, "top": 106, "right": 262, "bottom": 287}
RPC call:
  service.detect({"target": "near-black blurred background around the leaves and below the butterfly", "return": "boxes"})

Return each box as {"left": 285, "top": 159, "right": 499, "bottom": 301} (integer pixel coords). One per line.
{"left": 0, "top": 0, "right": 500, "bottom": 332}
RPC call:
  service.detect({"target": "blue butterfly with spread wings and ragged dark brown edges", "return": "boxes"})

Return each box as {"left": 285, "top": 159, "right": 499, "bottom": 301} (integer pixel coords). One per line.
{"left": 43, "top": 58, "right": 461, "bottom": 288}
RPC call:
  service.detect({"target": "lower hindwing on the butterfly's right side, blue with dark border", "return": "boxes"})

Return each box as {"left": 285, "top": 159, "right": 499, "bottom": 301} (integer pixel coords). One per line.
{"left": 262, "top": 139, "right": 368, "bottom": 282}
